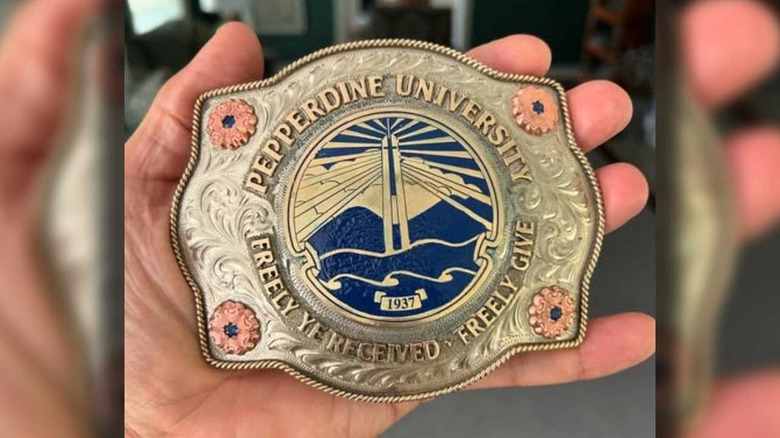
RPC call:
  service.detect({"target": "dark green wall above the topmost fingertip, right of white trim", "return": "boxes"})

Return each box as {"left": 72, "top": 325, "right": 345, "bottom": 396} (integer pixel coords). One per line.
{"left": 471, "top": 0, "right": 590, "bottom": 64}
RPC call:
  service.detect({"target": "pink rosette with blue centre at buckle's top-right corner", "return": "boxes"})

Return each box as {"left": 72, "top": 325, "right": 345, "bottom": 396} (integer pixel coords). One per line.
{"left": 512, "top": 85, "right": 558, "bottom": 135}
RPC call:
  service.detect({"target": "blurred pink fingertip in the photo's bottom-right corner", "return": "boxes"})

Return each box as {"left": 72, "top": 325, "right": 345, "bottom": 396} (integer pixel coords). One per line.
{"left": 688, "top": 370, "right": 780, "bottom": 438}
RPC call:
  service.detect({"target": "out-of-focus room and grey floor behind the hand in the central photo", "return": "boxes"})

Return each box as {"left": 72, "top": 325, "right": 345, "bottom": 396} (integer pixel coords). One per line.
{"left": 125, "top": 0, "right": 655, "bottom": 437}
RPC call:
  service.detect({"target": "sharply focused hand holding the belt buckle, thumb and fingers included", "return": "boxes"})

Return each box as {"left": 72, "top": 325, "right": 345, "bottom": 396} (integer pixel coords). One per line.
{"left": 125, "top": 23, "right": 655, "bottom": 436}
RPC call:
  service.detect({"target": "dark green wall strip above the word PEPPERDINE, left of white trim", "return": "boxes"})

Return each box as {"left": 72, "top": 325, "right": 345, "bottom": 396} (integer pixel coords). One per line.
{"left": 260, "top": 0, "right": 333, "bottom": 59}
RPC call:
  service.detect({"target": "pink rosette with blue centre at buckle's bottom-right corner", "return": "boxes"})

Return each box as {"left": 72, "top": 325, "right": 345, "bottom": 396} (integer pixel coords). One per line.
{"left": 528, "top": 286, "right": 576, "bottom": 339}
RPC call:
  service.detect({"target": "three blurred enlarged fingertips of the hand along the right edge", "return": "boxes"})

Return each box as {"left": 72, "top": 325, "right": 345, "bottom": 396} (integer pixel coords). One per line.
{"left": 682, "top": 0, "right": 780, "bottom": 438}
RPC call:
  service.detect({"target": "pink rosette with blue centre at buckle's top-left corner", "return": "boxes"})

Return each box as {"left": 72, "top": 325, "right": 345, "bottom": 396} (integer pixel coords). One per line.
{"left": 206, "top": 99, "right": 257, "bottom": 149}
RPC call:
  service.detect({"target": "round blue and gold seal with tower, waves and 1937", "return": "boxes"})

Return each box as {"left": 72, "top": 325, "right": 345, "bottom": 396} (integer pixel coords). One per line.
{"left": 285, "top": 108, "right": 499, "bottom": 323}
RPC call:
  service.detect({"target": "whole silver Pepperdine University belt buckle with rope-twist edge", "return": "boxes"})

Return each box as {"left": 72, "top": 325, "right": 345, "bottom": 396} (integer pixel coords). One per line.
{"left": 171, "top": 40, "right": 604, "bottom": 402}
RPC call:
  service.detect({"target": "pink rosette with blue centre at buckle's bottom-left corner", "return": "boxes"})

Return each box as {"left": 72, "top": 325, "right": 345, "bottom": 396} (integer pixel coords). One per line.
{"left": 209, "top": 300, "right": 260, "bottom": 355}
